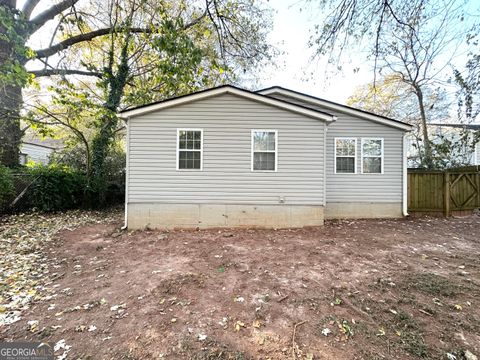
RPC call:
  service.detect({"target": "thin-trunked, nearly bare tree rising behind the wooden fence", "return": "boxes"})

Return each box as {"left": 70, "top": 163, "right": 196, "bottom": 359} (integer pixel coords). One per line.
{"left": 310, "top": 0, "right": 470, "bottom": 168}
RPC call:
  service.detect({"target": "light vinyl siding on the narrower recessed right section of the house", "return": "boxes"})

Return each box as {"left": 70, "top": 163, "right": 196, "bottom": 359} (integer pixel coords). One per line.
{"left": 269, "top": 94, "right": 404, "bottom": 203}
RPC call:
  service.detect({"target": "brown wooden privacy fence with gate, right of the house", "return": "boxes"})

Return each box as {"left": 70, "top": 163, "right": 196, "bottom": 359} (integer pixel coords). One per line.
{"left": 408, "top": 168, "right": 480, "bottom": 216}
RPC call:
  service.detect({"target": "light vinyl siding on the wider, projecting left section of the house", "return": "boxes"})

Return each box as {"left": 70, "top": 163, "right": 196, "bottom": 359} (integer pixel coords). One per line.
{"left": 127, "top": 94, "right": 325, "bottom": 205}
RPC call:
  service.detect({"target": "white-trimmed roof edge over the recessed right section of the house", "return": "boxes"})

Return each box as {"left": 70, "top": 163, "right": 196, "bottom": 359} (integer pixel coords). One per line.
{"left": 257, "top": 86, "right": 413, "bottom": 131}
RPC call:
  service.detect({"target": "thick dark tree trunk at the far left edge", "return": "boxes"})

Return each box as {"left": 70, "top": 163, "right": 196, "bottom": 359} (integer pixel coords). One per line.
{"left": 0, "top": 0, "right": 22, "bottom": 167}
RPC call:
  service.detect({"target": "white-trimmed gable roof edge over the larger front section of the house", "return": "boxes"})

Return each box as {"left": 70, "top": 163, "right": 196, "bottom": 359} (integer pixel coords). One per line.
{"left": 118, "top": 85, "right": 336, "bottom": 122}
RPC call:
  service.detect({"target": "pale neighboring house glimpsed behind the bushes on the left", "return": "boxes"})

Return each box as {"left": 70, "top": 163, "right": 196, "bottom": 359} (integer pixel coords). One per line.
{"left": 19, "top": 134, "right": 63, "bottom": 165}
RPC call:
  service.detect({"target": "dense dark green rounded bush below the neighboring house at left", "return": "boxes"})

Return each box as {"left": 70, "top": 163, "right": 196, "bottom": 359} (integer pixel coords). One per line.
{"left": 27, "top": 164, "right": 86, "bottom": 211}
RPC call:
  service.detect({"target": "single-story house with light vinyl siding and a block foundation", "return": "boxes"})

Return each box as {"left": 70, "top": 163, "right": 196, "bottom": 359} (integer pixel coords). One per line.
{"left": 119, "top": 85, "right": 411, "bottom": 229}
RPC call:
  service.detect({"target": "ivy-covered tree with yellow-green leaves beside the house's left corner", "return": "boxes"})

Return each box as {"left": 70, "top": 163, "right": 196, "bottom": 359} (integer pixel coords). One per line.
{"left": 21, "top": 0, "right": 269, "bottom": 205}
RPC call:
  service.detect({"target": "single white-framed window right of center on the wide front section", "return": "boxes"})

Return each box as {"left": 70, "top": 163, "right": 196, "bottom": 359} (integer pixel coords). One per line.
{"left": 252, "top": 130, "right": 277, "bottom": 171}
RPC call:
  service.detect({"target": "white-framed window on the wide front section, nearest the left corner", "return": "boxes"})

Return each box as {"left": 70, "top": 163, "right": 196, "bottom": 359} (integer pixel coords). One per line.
{"left": 177, "top": 129, "right": 203, "bottom": 170}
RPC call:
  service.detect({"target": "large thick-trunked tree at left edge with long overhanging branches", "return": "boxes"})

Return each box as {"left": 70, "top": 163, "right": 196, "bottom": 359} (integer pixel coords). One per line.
{"left": 0, "top": 0, "right": 269, "bottom": 166}
